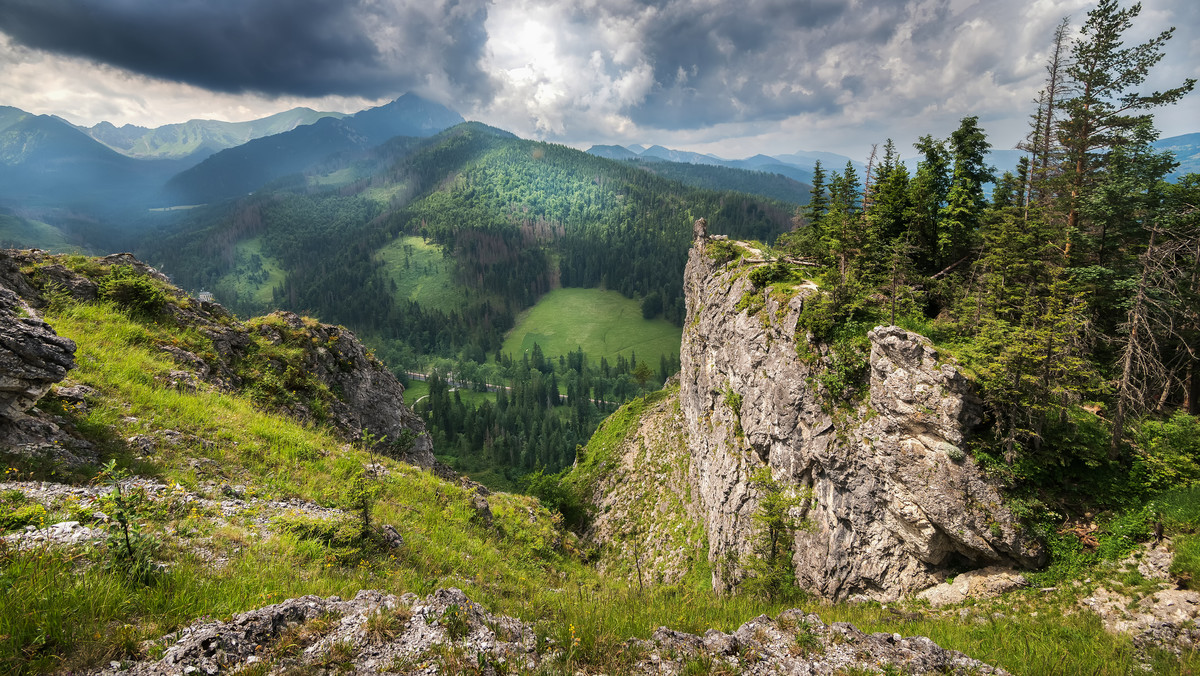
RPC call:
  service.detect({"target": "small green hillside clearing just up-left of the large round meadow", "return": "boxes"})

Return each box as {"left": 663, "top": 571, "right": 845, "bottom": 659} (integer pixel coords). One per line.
{"left": 378, "top": 237, "right": 467, "bottom": 312}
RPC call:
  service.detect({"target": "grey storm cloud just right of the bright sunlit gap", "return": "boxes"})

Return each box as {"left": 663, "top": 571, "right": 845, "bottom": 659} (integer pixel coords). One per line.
{"left": 556, "top": 0, "right": 949, "bottom": 128}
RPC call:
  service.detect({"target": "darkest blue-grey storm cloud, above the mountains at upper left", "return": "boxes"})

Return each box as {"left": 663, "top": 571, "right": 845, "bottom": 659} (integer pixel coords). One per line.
{"left": 0, "top": 0, "right": 488, "bottom": 98}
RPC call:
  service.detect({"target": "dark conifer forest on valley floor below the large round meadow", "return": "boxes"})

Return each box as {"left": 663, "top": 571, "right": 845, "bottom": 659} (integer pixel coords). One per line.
{"left": 414, "top": 343, "right": 679, "bottom": 481}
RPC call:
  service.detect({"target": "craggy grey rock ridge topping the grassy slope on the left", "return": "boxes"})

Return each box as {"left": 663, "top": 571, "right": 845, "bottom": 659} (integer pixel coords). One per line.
{"left": 0, "top": 250, "right": 434, "bottom": 467}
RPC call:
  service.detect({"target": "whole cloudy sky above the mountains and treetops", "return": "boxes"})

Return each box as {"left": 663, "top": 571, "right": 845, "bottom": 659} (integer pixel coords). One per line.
{"left": 0, "top": 0, "right": 1200, "bottom": 161}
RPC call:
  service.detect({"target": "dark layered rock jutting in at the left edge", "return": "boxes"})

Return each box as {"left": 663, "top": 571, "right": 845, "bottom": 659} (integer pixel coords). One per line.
{"left": 0, "top": 286, "right": 76, "bottom": 420}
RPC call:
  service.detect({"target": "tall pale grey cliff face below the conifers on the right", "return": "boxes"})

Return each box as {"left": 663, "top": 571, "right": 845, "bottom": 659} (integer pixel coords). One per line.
{"left": 679, "top": 244, "right": 1042, "bottom": 600}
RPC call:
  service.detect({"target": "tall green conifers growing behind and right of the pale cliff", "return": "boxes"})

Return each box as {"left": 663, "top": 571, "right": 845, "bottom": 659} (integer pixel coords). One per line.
{"left": 779, "top": 1, "right": 1200, "bottom": 504}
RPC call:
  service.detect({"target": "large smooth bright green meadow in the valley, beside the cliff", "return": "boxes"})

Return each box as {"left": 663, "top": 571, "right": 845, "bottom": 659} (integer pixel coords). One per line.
{"left": 500, "top": 288, "right": 683, "bottom": 367}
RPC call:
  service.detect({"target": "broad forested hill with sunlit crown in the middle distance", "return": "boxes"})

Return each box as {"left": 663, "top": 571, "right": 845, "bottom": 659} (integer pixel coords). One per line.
{"left": 142, "top": 122, "right": 794, "bottom": 355}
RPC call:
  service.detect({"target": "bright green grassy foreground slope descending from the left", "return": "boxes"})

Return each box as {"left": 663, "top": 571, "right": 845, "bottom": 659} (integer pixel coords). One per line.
{"left": 0, "top": 261, "right": 1200, "bottom": 675}
